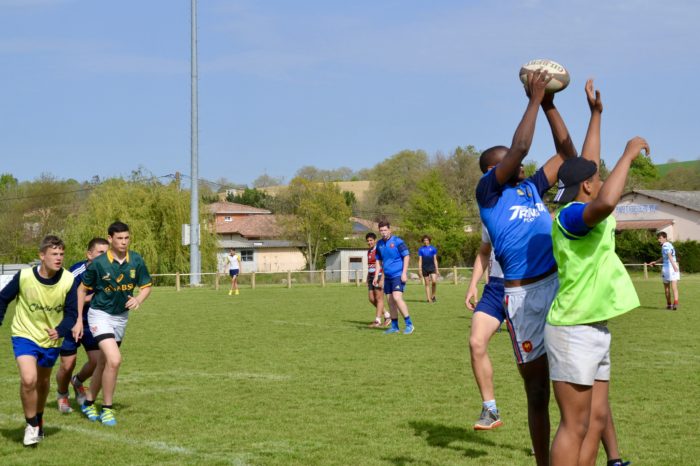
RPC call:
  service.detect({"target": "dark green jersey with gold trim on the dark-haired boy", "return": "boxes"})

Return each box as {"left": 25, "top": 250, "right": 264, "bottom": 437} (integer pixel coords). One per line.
{"left": 83, "top": 251, "right": 151, "bottom": 314}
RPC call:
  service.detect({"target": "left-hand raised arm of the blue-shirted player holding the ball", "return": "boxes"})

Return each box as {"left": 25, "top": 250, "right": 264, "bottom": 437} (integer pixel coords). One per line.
{"left": 495, "top": 70, "right": 552, "bottom": 185}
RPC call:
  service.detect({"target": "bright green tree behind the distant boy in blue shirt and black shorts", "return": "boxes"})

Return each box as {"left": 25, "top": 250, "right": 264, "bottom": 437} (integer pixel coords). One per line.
{"left": 402, "top": 170, "right": 466, "bottom": 264}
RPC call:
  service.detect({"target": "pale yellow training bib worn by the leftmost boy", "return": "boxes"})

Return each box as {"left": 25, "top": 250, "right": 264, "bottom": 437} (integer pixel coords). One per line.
{"left": 12, "top": 267, "right": 75, "bottom": 348}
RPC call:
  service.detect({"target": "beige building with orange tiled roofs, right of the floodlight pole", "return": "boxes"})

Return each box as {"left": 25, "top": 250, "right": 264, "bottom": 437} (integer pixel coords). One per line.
{"left": 209, "top": 202, "right": 306, "bottom": 273}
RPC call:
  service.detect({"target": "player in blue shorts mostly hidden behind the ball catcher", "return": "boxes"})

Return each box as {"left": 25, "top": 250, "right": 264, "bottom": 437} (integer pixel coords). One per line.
{"left": 464, "top": 226, "right": 505, "bottom": 430}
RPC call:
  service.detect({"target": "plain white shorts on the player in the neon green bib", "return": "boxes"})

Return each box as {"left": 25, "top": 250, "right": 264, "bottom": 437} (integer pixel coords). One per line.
{"left": 544, "top": 323, "right": 610, "bottom": 387}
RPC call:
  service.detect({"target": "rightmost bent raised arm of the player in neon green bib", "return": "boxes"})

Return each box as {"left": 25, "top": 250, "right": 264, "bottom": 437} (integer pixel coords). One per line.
{"left": 583, "top": 137, "right": 650, "bottom": 228}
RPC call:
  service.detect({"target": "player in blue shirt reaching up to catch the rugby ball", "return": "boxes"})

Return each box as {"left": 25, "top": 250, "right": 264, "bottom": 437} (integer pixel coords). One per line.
{"left": 476, "top": 70, "right": 576, "bottom": 466}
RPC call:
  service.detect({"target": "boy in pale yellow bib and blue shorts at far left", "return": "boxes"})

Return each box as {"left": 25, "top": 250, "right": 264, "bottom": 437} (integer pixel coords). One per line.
{"left": 0, "top": 236, "right": 77, "bottom": 446}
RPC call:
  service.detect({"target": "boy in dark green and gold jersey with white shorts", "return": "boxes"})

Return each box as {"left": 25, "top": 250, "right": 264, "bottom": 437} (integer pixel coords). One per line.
{"left": 76, "top": 222, "right": 152, "bottom": 426}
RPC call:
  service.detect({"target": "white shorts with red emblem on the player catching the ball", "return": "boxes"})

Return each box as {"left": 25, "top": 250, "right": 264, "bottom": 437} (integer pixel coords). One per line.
{"left": 505, "top": 272, "right": 559, "bottom": 364}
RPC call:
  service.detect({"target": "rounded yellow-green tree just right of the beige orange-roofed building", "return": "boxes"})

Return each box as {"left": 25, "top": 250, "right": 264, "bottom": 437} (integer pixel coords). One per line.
{"left": 282, "top": 177, "right": 352, "bottom": 271}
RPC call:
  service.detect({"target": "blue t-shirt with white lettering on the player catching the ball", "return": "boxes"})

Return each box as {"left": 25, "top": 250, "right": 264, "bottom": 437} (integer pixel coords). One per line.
{"left": 476, "top": 168, "right": 556, "bottom": 280}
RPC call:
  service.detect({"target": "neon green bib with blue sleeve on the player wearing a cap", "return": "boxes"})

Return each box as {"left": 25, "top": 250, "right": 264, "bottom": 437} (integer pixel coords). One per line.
{"left": 547, "top": 203, "right": 639, "bottom": 325}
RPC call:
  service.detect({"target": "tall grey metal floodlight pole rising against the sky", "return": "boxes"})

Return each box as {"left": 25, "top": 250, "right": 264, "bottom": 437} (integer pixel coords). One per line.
{"left": 190, "top": 0, "right": 202, "bottom": 286}
